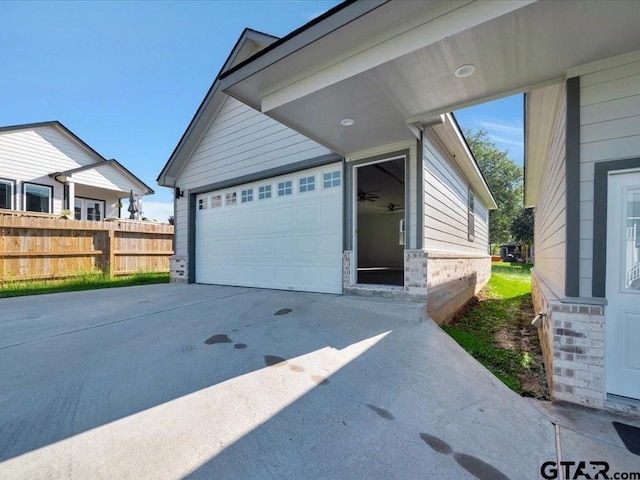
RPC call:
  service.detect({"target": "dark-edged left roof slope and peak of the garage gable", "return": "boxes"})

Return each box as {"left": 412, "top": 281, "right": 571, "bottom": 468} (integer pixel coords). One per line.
{"left": 157, "top": 28, "right": 278, "bottom": 187}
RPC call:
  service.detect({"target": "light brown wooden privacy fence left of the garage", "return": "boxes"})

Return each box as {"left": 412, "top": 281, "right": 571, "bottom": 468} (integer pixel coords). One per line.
{"left": 0, "top": 211, "right": 173, "bottom": 281}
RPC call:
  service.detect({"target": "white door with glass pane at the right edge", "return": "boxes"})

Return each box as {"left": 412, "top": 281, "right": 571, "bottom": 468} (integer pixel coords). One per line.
{"left": 606, "top": 172, "right": 640, "bottom": 399}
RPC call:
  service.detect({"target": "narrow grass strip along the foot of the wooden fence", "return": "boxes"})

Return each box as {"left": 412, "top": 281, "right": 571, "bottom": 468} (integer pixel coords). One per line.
{"left": 0, "top": 273, "right": 169, "bottom": 298}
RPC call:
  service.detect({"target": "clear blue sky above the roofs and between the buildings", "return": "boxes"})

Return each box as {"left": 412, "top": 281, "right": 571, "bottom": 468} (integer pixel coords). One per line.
{"left": 0, "top": 0, "right": 522, "bottom": 221}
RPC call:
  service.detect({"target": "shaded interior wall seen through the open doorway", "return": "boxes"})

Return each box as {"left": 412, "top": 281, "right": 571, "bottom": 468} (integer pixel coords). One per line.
{"left": 358, "top": 212, "right": 405, "bottom": 268}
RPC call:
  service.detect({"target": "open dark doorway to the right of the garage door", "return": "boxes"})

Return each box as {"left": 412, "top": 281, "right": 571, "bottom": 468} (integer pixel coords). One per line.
{"left": 355, "top": 157, "right": 405, "bottom": 286}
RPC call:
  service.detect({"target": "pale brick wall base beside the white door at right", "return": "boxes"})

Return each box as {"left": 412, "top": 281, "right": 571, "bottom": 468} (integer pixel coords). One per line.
{"left": 531, "top": 269, "right": 606, "bottom": 408}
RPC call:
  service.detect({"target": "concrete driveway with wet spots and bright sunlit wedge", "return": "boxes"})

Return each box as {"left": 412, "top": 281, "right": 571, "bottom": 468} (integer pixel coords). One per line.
{"left": 0, "top": 285, "right": 632, "bottom": 480}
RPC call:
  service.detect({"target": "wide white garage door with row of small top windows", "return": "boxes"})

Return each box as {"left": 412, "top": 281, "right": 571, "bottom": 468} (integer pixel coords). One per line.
{"left": 196, "top": 163, "right": 342, "bottom": 293}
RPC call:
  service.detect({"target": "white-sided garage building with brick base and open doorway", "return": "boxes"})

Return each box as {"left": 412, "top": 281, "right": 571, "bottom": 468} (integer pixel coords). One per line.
{"left": 158, "top": 30, "right": 495, "bottom": 321}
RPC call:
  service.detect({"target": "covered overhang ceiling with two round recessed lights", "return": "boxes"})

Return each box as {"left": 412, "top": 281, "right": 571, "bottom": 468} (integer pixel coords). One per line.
{"left": 220, "top": 0, "right": 640, "bottom": 157}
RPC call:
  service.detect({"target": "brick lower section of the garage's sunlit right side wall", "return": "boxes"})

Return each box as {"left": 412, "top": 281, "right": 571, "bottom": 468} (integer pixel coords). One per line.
{"left": 425, "top": 252, "right": 491, "bottom": 324}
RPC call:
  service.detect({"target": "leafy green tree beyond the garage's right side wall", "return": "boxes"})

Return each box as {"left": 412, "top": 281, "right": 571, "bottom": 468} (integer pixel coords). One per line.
{"left": 464, "top": 129, "right": 523, "bottom": 249}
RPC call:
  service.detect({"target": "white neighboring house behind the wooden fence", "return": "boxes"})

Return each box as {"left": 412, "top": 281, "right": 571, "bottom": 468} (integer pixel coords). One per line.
{"left": 0, "top": 121, "right": 153, "bottom": 220}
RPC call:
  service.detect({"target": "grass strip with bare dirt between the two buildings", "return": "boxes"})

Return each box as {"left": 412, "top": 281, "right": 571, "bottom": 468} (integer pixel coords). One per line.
{"left": 443, "top": 263, "right": 540, "bottom": 395}
